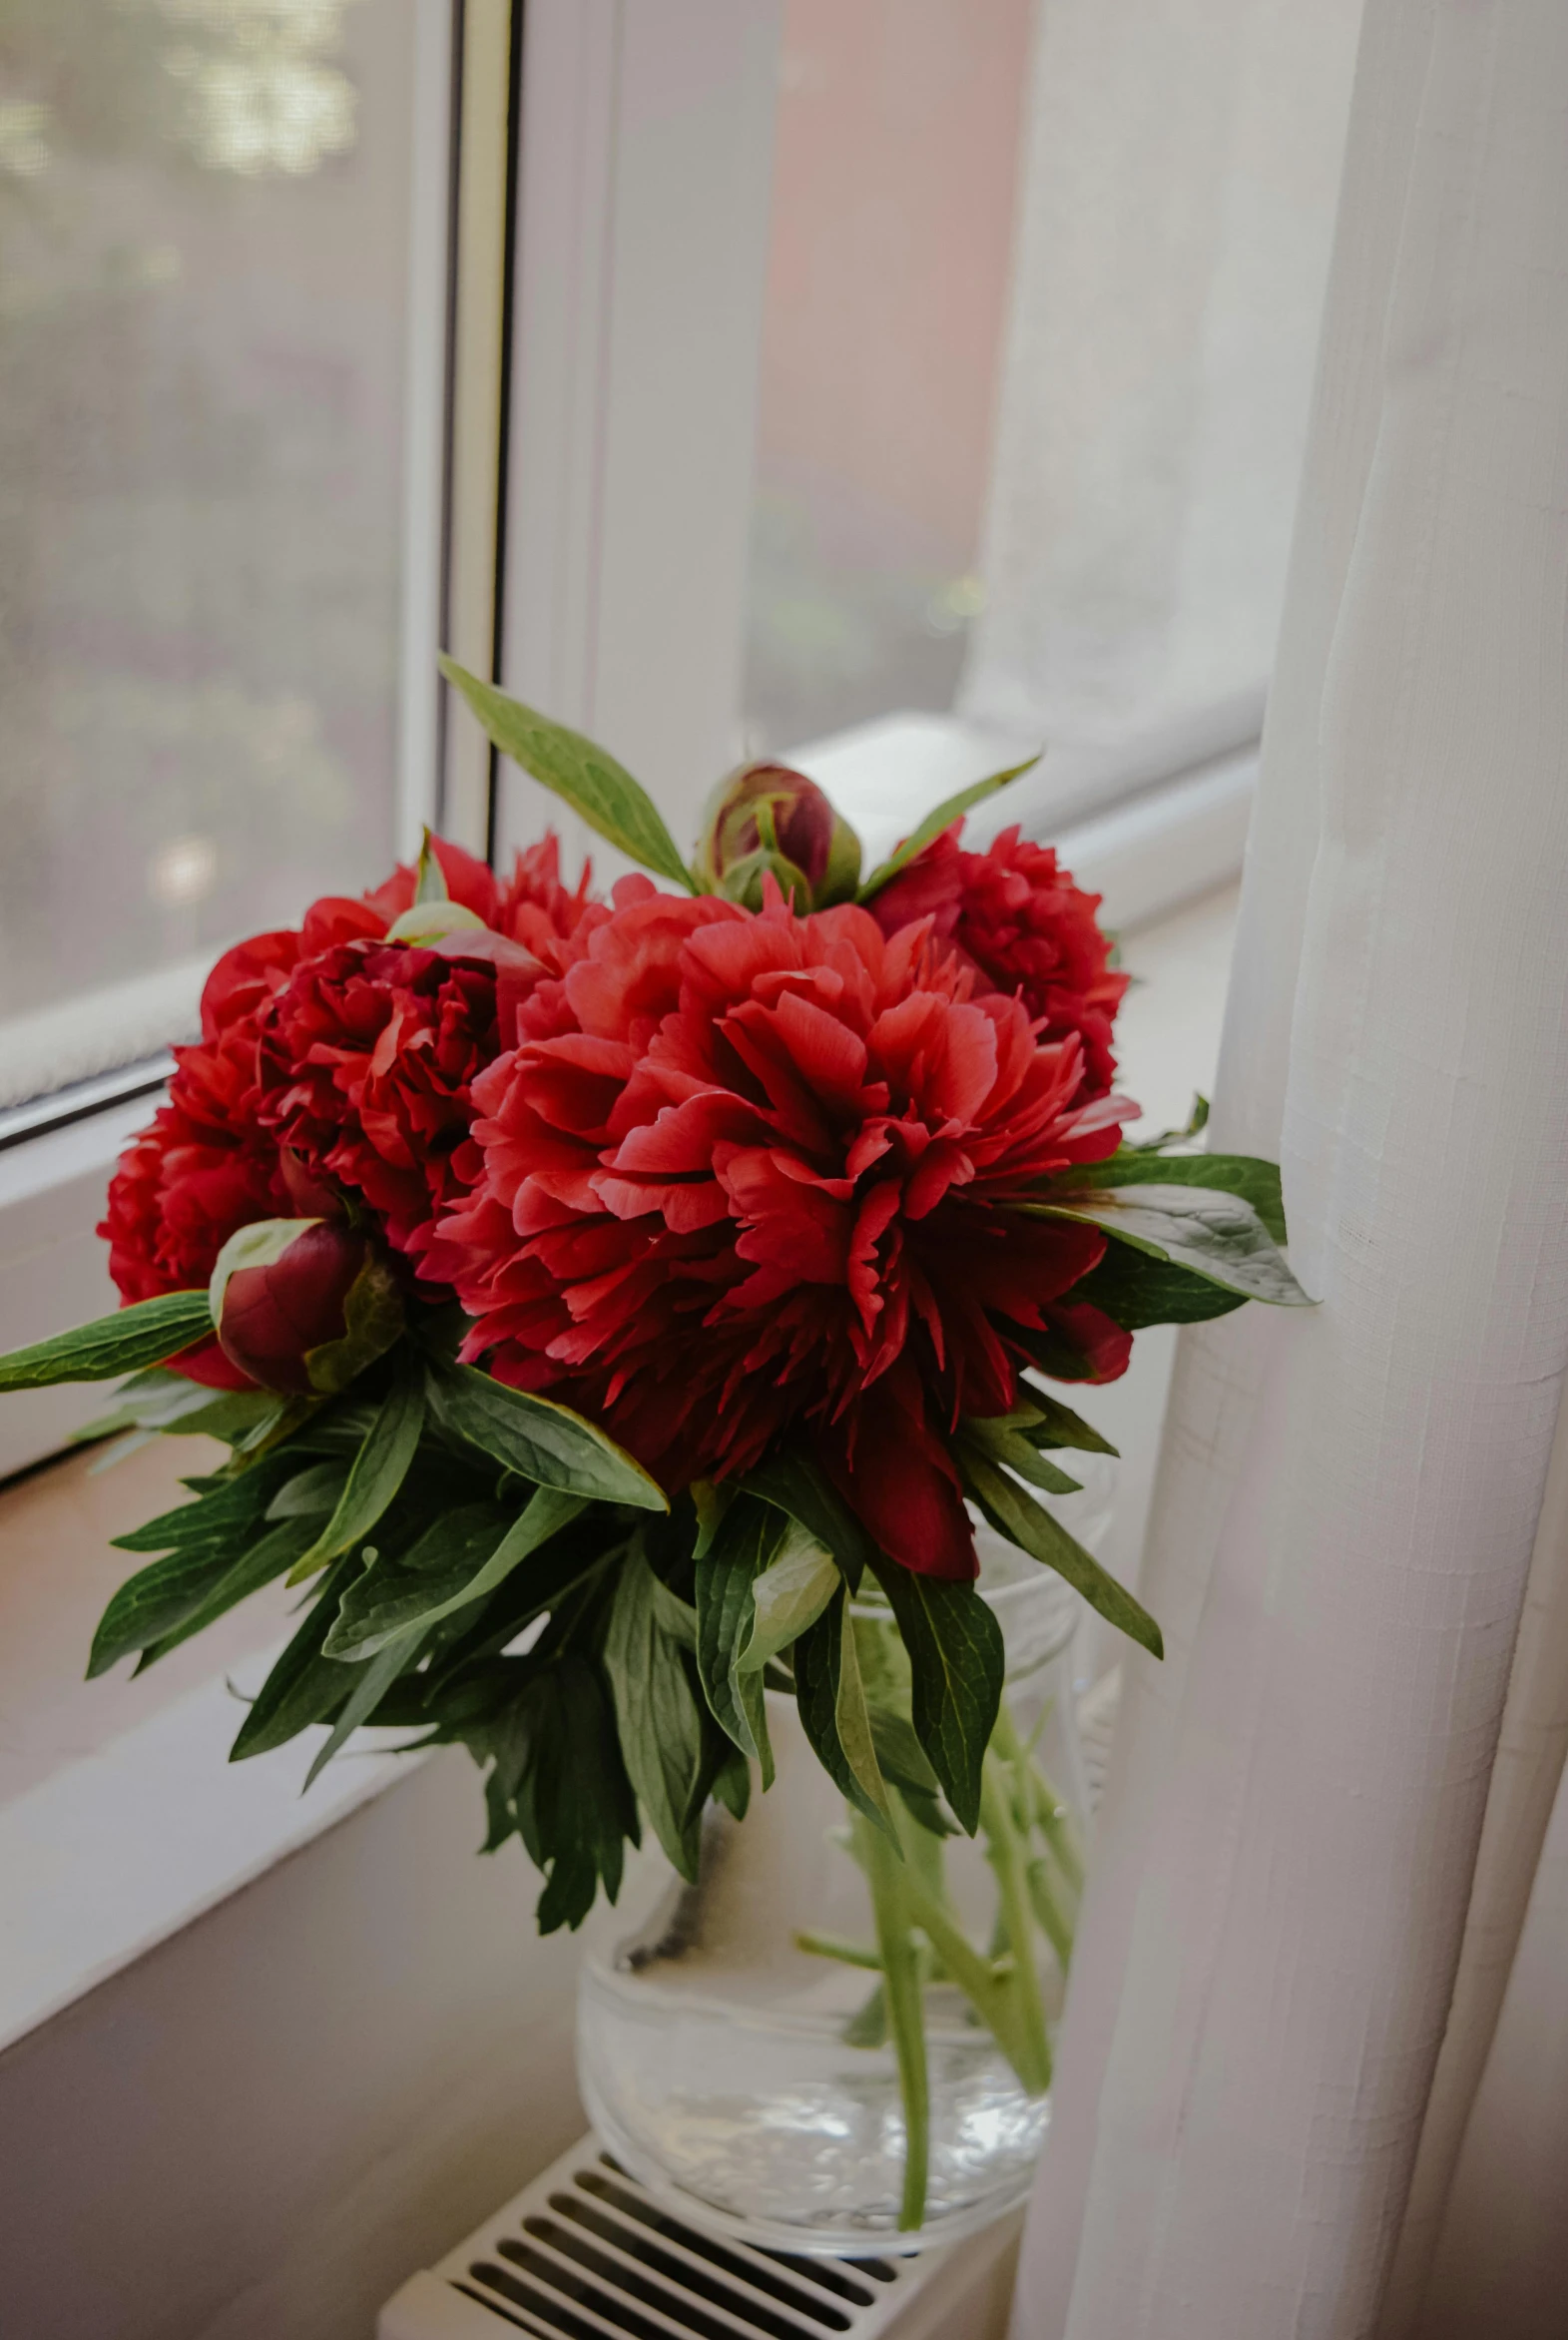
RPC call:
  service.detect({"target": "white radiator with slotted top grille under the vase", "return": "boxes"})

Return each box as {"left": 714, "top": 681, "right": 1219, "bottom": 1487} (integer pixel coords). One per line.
{"left": 377, "top": 2136, "right": 1020, "bottom": 2340}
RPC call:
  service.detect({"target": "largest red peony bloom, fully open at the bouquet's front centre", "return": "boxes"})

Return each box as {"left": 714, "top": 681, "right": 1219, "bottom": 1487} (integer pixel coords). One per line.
{"left": 421, "top": 879, "right": 1128, "bottom": 1577}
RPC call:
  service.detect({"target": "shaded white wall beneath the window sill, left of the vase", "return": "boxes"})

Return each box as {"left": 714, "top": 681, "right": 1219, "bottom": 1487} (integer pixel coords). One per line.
{"left": 0, "top": 1753, "right": 583, "bottom": 2340}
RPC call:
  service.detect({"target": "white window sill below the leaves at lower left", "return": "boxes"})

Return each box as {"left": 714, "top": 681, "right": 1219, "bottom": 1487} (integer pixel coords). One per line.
{"left": 0, "top": 1440, "right": 421, "bottom": 2049}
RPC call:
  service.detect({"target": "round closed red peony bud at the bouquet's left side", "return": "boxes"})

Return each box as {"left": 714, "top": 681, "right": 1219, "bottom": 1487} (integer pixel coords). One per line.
{"left": 209, "top": 1219, "right": 402, "bottom": 1397}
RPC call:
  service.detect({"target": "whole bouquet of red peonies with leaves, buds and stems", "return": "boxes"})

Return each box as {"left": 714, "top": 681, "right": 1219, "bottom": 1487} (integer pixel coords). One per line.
{"left": 0, "top": 665, "right": 1302, "bottom": 2235}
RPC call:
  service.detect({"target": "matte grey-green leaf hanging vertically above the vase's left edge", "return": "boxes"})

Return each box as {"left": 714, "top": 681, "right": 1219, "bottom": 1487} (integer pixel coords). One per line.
{"left": 604, "top": 1551, "right": 705, "bottom": 1884}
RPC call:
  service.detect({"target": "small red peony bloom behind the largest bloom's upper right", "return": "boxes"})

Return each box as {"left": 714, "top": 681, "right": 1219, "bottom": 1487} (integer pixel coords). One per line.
{"left": 870, "top": 822, "right": 1128, "bottom": 1097}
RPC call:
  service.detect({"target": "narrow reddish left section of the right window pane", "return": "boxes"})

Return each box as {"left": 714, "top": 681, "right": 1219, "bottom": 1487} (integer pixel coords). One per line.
{"left": 745, "top": 0, "right": 1034, "bottom": 754}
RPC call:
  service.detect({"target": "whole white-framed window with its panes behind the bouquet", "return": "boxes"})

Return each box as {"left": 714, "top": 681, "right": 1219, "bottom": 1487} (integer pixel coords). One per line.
{"left": 0, "top": 0, "right": 1359, "bottom": 1467}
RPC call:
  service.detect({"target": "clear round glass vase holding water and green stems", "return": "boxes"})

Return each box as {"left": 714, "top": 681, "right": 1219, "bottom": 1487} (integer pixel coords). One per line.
{"left": 578, "top": 1497, "right": 1095, "bottom": 2251}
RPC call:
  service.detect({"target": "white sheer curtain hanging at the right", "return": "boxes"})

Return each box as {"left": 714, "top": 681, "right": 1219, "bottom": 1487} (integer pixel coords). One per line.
{"left": 1013, "top": 0, "right": 1568, "bottom": 2340}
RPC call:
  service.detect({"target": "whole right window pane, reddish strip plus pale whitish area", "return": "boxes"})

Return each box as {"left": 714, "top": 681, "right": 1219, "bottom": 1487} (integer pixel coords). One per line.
{"left": 747, "top": 0, "right": 1359, "bottom": 751}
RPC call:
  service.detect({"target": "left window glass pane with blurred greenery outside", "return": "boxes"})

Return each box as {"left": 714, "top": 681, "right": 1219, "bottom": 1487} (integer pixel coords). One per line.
{"left": 0, "top": 0, "right": 440, "bottom": 1102}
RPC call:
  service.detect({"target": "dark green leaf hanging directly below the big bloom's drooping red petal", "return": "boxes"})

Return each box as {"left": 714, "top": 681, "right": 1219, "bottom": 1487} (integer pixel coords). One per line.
{"left": 875, "top": 1553, "right": 1004, "bottom": 1837}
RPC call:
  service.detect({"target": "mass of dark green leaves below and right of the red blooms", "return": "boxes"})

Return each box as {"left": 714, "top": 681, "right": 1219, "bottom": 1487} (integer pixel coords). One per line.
{"left": 0, "top": 1099, "right": 1304, "bottom": 1931}
